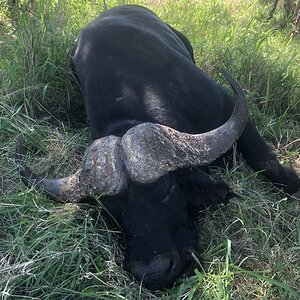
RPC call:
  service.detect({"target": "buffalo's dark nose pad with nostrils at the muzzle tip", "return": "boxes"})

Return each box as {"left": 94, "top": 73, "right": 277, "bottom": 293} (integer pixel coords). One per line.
{"left": 128, "top": 255, "right": 172, "bottom": 280}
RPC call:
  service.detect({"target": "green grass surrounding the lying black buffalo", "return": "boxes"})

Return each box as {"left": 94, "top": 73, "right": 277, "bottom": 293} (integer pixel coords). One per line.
{"left": 0, "top": 0, "right": 300, "bottom": 300}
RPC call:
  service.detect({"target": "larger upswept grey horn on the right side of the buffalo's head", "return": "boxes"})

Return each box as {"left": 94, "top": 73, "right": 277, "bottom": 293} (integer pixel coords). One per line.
{"left": 122, "top": 71, "right": 248, "bottom": 183}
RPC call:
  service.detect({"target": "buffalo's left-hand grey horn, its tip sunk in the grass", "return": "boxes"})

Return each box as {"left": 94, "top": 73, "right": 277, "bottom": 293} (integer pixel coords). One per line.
{"left": 15, "top": 136, "right": 127, "bottom": 202}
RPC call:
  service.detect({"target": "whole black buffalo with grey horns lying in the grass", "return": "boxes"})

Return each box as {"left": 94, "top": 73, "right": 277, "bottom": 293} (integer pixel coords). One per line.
{"left": 17, "top": 6, "right": 300, "bottom": 288}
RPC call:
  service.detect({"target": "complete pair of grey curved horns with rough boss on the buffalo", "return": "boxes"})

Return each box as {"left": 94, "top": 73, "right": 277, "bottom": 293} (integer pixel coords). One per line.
{"left": 16, "top": 71, "right": 248, "bottom": 202}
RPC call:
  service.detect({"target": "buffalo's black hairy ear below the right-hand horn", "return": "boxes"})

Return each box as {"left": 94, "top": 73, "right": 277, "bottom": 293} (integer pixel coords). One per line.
{"left": 180, "top": 168, "right": 235, "bottom": 214}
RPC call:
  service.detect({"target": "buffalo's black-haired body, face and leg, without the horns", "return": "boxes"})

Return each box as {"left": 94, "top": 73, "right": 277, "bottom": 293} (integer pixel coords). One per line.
{"left": 73, "top": 6, "right": 300, "bottom": 288}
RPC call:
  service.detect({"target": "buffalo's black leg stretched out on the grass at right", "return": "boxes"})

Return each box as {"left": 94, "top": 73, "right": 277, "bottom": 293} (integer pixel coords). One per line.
{"left": 238, "top": 121, "right": 300, "bottom": 194}
